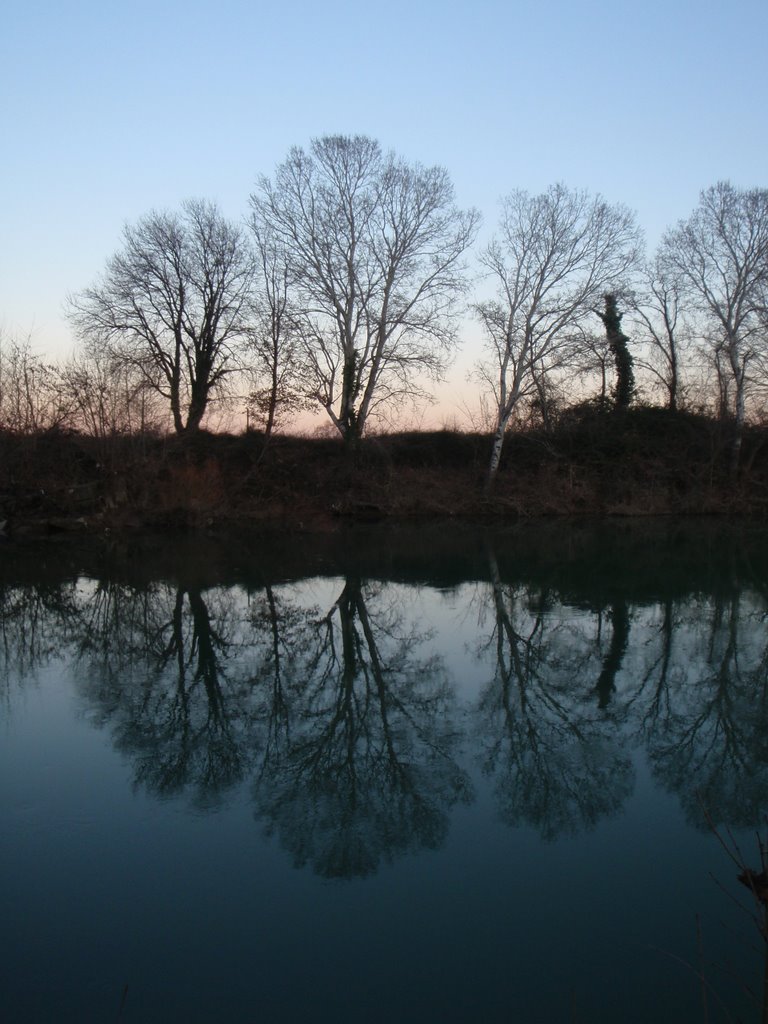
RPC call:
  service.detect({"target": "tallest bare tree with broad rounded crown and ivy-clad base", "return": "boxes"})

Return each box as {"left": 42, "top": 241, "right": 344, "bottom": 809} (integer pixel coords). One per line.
{"left": 251, "top": 135, "right": 478, "bottom": 442}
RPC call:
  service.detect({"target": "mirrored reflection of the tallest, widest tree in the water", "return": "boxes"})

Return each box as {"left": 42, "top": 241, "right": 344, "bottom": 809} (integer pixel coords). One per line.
{"left": 250, "top": 578, "right": 469, "bottom": 878}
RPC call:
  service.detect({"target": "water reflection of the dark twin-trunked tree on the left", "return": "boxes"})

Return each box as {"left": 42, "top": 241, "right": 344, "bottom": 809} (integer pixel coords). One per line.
{"left": 72, "top": 583, "right": 253, "bottom": 806}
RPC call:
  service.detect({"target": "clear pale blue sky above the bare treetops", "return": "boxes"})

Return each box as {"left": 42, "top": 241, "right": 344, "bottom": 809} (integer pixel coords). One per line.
{"left": 0, "top": 0, "right": 768, "bottom": 423}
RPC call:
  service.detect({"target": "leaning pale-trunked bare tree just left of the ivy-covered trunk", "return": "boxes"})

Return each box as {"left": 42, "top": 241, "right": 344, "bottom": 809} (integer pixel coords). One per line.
{"left": 475, "top": 184, "right": 640, "bottom": 487}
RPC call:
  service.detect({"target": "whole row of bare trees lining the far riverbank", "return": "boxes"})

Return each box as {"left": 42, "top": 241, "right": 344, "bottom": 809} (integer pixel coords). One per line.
{"left": 0, "top": 136, "right": 768, "bottom": 476}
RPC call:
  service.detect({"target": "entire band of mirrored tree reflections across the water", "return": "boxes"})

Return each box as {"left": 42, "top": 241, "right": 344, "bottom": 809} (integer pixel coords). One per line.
{"left": 0, "top": 524, "right": 768, "bottom": 877}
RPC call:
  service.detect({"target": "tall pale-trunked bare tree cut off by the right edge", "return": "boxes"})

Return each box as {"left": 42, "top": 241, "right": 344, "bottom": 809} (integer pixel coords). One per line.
{"left": 660, "top": 181, "right": 768, "bottom": 469}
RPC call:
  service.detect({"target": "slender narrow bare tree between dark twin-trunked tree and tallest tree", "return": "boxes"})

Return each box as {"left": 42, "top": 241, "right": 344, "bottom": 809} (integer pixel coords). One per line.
{"left": 246, "top": 220, "right": 307, "bottom": 437}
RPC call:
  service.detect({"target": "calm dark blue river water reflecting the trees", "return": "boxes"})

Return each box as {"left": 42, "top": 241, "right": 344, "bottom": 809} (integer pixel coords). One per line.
{"left": 0, "top": 523, "right": 768, "bottom": 1024}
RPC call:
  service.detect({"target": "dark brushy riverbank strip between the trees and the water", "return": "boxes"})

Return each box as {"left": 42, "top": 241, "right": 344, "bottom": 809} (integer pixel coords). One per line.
{"left": 0, "top": 409, "right": 768, "bottom": 537}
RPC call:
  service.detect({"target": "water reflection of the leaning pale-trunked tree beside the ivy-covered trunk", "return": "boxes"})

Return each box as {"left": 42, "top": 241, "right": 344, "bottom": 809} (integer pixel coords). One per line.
{"left": 477, "top": 553, "right": 633, "bottom": 840}
